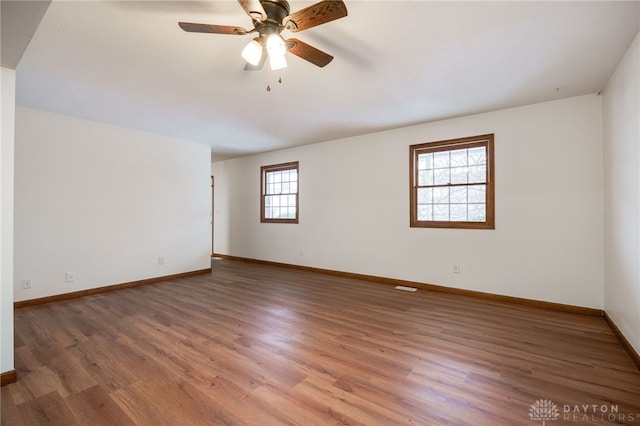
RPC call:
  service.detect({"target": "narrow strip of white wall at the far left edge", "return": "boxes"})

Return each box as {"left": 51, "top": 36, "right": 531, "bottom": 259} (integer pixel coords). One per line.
{"left": 0, "top": 68, "right": 16, "bottom": 373}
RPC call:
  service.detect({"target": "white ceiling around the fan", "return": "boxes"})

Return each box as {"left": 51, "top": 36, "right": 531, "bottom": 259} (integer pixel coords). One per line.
{"left": 3, "top": 0, "right": 640, "bottom": 159}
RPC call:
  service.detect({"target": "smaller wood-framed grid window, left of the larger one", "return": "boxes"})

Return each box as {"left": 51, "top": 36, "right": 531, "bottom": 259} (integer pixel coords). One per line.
{"left": 260, "top": 161, "right": 298, "bottom": 223}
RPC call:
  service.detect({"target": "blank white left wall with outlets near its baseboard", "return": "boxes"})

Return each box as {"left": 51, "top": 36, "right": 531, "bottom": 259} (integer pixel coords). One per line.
{"left": 14, "top": 107, "right": 211, "bottom": 301}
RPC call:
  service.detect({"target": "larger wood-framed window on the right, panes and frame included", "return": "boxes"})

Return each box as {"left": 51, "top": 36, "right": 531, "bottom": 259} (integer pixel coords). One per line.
{"left": 409, "top": 134, "right": 495, "bottom": 229}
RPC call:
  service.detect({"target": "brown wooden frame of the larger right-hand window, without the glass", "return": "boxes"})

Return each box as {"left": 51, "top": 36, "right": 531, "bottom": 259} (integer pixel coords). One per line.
{"left": 409, "top": 133, "right": 495, "bottom": 229}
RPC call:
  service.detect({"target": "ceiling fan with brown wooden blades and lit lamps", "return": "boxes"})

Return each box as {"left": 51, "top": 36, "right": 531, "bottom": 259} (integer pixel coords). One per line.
{"left": 178, "top": 0, "right": 347, "bottom": 70}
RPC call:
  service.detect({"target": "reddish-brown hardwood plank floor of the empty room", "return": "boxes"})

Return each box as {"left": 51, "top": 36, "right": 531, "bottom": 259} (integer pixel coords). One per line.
{"left": 1, "top": 260, "right": 640, "bottom": 426}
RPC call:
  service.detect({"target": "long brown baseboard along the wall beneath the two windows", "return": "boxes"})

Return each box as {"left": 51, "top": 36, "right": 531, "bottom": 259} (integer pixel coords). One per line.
{"left": 215, "top": 253, "right": 603, "bottom": 317}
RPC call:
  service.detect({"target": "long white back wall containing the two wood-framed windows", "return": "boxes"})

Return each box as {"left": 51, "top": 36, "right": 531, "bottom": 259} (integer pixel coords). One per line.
{"left": 212, "top": 94, "right": 604, "bottom": 308}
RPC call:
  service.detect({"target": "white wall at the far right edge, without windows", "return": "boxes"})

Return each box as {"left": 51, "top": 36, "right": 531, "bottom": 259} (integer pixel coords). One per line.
{"left": 603, "top": 31, "right": 640, "bottom": 353}
